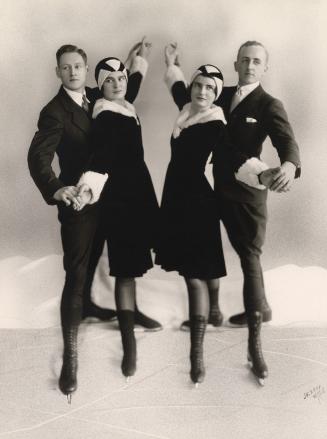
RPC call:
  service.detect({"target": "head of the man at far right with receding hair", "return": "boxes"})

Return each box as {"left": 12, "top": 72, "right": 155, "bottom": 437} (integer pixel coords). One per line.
{"left": 234, "top": 46, "right": 268, "bottom": 85}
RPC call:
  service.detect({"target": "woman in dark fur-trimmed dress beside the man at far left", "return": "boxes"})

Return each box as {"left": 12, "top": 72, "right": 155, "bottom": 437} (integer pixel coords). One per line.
{"left": 79, "top": 58, "right": 159, "bottom": 377}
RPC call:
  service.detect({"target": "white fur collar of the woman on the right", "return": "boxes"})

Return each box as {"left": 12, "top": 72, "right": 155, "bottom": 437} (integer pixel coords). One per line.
{"left": 173, "top": 103, "right": 227, "bottom": 139}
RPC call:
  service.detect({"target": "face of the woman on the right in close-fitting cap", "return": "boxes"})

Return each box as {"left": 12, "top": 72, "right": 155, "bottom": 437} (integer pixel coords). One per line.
{"left": 191, "top": 75, "right": 216, "bottom": 111}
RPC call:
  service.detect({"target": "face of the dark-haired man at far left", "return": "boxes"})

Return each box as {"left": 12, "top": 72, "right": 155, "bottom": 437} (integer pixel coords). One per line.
{"left": 56, "top": 52, "right": 88, "bottom": 93}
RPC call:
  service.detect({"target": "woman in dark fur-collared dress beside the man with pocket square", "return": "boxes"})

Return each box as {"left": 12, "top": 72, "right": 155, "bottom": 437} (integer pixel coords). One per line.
{"left": 156, "top": 52, "right": 226, "bottom": 384}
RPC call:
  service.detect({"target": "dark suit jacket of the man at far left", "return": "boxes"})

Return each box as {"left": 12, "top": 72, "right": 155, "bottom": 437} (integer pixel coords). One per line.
{"left": 28, "top": 72, "right": 142, "bottom": 204}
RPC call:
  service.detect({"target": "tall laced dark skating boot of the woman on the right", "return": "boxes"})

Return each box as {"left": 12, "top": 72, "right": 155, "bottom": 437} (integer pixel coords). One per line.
{"left": 190, "top": 315, "right": 207, "bottom": 385}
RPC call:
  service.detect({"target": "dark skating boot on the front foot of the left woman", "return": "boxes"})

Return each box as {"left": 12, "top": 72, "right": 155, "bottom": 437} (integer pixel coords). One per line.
{"left": 117, "top": 310, "right": 136, "bottom": 378}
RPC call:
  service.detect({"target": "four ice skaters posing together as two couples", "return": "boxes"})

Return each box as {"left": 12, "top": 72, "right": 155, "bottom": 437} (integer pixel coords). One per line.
{"left": 28, "top": 36, "right": 300, "bottom": 396}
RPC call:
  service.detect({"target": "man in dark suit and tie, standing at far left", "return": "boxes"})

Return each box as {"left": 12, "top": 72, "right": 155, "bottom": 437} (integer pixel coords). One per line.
{"left": 28, "top": 41, "right": 161, "bottom": 395}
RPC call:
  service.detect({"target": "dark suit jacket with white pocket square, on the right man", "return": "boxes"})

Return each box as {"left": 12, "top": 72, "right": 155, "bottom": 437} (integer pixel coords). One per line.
{"left": 171, "top": 81, "right": 300, "bottom": 203}
